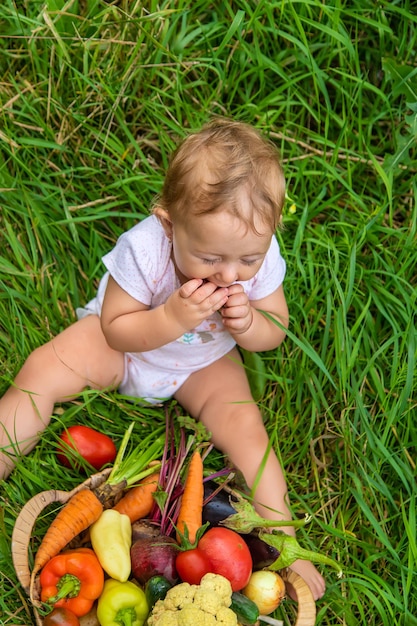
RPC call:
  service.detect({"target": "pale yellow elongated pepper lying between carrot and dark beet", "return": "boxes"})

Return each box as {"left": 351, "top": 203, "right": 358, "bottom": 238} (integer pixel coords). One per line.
{"left": 90, "top": 509, "right": 132, "bottom": 582}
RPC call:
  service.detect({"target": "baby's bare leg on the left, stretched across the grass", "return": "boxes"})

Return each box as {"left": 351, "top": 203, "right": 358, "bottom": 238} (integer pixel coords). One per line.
{"left": 0, "top": 315, "right": 123, "bottom": 478}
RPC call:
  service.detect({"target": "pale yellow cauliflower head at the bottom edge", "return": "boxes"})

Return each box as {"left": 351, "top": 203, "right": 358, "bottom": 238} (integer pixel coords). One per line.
{"left": 148, "top": 573, "right": 237, "bottom": 626}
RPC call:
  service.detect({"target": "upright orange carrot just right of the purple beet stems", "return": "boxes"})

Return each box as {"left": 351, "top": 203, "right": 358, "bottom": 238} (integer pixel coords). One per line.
{"left": 177, "top": 450, "right": 204, "bottom": 543}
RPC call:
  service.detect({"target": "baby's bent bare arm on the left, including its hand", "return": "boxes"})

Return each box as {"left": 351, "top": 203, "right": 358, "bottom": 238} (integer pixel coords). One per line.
{"left": 101, "top": 277, "right": 227, "bottom": 352}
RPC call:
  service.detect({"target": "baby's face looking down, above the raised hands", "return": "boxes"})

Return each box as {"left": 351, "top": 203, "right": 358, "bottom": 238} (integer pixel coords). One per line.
{"left": 172, "top": 211, "right": 273, "bottom": 287}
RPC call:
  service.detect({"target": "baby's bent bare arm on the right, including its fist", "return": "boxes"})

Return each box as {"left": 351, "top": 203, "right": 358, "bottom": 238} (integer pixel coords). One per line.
{"left": 221, "top": 284, "right": 288, "bottom": 352}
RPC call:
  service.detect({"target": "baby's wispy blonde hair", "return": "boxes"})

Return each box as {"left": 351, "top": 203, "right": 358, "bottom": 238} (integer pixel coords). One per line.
{"left": 157, "top": 118, "right": 285, "bottom": 231}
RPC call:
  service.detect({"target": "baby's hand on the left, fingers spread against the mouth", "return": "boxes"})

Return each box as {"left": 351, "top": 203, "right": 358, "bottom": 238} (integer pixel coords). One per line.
{"left": 165, "top": 278, "right": 229, "bottom": 332}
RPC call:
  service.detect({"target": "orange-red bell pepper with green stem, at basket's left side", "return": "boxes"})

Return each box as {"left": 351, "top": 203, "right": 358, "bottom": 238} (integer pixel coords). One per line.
{"left": 39, "top": 548, "right": 104, "bottom": 617}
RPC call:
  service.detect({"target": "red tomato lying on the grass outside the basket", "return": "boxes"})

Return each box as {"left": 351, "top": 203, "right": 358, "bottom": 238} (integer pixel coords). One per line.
{"left": 57, "top": 426, "right": 117, "bottom": 470}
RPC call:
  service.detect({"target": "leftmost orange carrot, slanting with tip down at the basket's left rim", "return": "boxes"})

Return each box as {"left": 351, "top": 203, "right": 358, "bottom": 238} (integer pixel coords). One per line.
{"left": 32, "top": 489, "right": 103, "bottom": 577}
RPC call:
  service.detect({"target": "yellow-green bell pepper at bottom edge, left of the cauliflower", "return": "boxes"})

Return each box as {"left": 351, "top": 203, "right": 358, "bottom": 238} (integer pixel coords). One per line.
{"left": 97, "top": 578, "right": 149, "bottom": 626}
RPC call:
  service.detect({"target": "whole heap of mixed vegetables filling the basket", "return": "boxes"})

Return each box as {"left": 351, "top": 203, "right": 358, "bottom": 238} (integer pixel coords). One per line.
{"left": 19, "top": 414, "right": 338, "bottom": 626}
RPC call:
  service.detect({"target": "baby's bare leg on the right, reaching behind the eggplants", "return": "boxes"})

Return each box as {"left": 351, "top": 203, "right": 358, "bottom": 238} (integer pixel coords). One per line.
{"left": 175, "top": 350, "right": 325, "bottom": 599}
